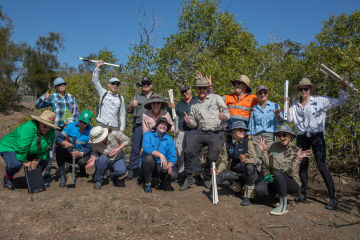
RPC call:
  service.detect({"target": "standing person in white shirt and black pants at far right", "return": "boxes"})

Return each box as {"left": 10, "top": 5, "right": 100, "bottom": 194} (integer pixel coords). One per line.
{"left": 288, "top": 78, "right": 348, "bottom": 210}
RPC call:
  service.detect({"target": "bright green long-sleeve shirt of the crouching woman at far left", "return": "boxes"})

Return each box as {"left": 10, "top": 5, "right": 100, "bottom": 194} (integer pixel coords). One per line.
{"left": 0, "top": 120, "right": 55, "bottom": 162}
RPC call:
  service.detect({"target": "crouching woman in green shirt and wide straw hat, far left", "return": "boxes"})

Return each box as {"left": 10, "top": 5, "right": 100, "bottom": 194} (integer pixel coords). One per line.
{"left": 0, "top": 110, "right": 58, "bottom": 190}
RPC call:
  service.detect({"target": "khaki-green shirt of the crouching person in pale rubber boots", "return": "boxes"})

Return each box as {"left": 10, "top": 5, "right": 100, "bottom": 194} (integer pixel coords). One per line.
{"left": 262, "top": 142, "right": 301, "bottom": 186}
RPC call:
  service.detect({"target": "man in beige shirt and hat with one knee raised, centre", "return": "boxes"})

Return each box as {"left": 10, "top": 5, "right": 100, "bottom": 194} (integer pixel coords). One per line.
{"left": 180, "top": 78, "right": 230, "bottom": 191}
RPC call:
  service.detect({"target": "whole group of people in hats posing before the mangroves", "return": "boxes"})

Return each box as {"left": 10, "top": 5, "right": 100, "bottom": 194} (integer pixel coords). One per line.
{"left": 0, "top": 60, "right": 348, "bottom": 215}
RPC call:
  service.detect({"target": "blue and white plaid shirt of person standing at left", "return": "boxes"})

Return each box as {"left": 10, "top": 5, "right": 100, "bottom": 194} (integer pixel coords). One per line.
{"left": 35, "top": 93, "right": 79, "bottom": 127}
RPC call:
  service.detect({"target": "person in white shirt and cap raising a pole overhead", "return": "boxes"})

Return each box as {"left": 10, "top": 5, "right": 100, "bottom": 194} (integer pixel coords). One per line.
{"left": 92, "top": 60, "right": 125, "bottom": 132}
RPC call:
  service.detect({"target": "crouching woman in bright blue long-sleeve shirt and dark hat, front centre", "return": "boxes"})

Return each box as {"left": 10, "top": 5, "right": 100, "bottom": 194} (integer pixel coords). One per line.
{"left": 140, "top": 117, "right": 179, "bottom": 193}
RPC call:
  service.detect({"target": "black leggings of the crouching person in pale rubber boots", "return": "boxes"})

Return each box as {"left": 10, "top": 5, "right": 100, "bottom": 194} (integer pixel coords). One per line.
{"left": 254, "top": 170, "right": 300, "bottom": 197}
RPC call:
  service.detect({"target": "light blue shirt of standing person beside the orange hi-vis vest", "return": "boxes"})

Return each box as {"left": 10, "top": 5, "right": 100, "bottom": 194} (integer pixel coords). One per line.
{"left": 248, "top": 100, "right": 284, "bottom": 135}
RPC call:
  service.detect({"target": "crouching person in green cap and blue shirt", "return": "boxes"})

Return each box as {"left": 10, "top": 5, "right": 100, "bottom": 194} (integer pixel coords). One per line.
{"left": 55, "top": 110, "right": 93, "bottom": 187}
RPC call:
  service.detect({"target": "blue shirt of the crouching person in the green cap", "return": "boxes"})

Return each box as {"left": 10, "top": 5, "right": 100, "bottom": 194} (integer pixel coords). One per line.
{"left": 55, "top": 122, "right": 92, "bottom": 155}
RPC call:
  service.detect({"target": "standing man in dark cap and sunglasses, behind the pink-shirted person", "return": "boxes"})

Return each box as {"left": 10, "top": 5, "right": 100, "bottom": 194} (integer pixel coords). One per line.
{"left": 126, "top": 77, "right": 160, "bottom": 180}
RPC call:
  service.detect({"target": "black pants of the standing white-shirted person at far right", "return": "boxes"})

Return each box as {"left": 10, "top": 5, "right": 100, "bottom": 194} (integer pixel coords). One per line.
{"left": 296, "top": 132, "right": 335, "bottom": 198}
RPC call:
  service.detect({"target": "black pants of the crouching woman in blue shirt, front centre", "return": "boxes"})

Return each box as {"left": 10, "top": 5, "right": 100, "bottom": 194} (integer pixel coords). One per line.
{"left": 141, "top": 154, "right": 179, "bottom": 183}
